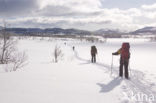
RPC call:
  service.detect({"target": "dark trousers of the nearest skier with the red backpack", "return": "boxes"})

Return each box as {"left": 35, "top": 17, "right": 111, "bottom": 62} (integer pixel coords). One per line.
{"left": 119, "top": 59, "right": 129, "bottom": 79}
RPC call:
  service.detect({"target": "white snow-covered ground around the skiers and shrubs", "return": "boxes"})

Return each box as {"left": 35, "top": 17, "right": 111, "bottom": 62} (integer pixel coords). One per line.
{"left": 0, "top": 38, "right": 156, "bottom": 103}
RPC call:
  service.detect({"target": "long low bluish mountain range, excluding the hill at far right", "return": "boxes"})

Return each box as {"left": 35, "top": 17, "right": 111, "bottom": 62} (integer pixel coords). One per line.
{"left": 3, "top": 28, "right": 123, "bottom": 35}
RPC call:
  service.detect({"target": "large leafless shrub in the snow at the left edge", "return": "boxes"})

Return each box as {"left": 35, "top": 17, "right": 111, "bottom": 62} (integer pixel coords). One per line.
{"left": 0, "top": 21, "right": 27, "bottom": 71}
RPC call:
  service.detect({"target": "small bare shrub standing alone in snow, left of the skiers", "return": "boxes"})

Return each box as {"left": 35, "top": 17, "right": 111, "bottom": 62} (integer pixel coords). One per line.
{"left": 54, "top": 45, "right": 63, "bottom": 63}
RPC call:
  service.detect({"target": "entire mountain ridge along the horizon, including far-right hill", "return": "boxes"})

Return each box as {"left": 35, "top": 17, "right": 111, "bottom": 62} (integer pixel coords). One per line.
{"left": 0, "top": 26, "right": 156, "bottom": 35}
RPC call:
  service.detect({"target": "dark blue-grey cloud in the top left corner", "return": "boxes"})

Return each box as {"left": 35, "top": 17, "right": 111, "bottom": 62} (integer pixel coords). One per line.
{"left": 0, "top": 0, "right": 38, "bottom": 16}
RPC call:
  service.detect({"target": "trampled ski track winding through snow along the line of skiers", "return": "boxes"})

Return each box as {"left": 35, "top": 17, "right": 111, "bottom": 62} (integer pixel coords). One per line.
{"left": 74, "top": 48, "right": 156, "bottom": 103}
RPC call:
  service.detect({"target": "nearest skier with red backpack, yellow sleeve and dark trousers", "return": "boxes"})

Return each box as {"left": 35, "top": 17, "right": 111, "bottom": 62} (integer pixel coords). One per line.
{"left": 112, "top": 43, "right": 130, "bottom": 79}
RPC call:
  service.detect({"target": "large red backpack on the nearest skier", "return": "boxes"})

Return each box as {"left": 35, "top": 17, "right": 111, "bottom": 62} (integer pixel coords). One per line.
{"left": 121, "top": 43, "right": 130, "bottom": 60}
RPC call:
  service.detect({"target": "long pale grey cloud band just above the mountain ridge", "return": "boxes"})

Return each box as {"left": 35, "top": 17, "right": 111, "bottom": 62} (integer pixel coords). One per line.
{"left": 9, "top": 19, "right": 112, "bottom": 29}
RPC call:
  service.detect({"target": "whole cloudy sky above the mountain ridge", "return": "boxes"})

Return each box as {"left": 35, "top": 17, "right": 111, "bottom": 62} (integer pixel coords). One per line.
{"left": 0, "top": 0, "right": 156, "bottom": 31}
